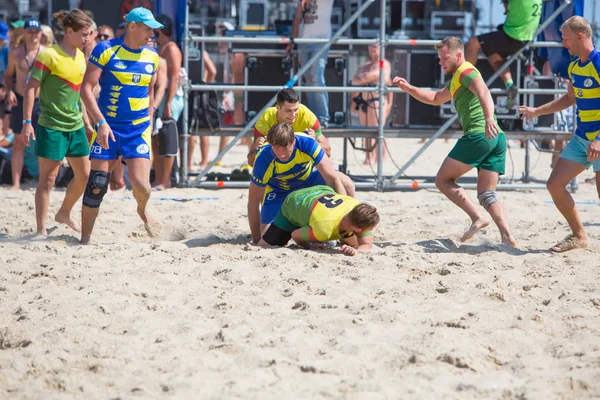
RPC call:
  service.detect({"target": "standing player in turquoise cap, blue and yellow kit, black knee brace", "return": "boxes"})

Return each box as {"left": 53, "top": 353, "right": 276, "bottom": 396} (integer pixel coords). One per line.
{"left": 81, "top": 7, "right": 163, "bottom": 244}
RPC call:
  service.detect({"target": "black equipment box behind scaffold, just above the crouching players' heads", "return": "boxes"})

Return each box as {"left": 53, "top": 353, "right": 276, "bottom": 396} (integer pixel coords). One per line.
{"left": 246, "top": 54, "right": 292, "bottom": 115}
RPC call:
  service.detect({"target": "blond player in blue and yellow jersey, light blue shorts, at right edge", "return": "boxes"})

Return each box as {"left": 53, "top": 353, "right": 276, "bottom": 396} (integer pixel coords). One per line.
{"left": 519, "top": 16, "right": 600, "bottom": 252}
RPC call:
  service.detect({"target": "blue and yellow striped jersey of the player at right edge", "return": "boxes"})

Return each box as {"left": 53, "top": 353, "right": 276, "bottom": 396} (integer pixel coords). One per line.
{"left": 569, "top": 49, "right": 600, "bottom": 140}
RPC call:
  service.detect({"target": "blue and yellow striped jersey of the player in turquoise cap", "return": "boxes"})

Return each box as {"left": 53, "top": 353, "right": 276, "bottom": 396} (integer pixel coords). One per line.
{"left": 89, "top": 37, "right": 158, "bottom": 130}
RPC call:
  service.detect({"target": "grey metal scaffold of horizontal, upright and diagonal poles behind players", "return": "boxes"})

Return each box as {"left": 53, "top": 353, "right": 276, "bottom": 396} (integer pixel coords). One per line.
{"left": 182, "top": 0, "right": 569, "bottom": 190}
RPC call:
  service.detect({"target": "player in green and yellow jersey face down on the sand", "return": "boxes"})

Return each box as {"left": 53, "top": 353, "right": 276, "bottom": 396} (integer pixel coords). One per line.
{"left": 258, "top": 186, "right": 379, "bottom": 256}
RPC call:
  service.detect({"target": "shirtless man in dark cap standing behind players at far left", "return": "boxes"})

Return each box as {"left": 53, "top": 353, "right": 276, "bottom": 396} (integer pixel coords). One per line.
{"left": 4, "top": 18, "right": 45, "bottom": 190}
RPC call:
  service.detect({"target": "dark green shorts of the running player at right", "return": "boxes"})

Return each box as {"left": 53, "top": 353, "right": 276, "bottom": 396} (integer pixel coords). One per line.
{"left": 448, "top": 133, "right": 506, "bottom": 175}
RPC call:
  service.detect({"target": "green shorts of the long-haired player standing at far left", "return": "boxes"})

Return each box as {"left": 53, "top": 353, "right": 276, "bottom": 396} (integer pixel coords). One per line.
{"left": 35, "top": 124, "right": 90, "bottom": 161}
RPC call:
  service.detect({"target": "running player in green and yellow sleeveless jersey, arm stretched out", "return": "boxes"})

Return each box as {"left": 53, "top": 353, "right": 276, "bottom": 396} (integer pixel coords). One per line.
{"left": 393, "top": 37, "right": 516, "bottom": 247}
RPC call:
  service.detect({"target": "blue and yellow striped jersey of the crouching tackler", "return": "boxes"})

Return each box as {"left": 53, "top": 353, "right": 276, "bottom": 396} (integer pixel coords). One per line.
{"left": 252, "top": 133, "right": 325, "bottom": 192}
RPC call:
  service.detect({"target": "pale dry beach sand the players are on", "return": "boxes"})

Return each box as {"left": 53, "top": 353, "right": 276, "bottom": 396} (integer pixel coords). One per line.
{"left": 0, "top": 140, "right": 600, "bottom": 399}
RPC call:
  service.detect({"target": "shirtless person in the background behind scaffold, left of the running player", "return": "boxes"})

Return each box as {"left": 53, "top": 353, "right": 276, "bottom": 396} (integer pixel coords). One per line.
{"left": 352, "top": 43, "right": 394, "bottom": 164}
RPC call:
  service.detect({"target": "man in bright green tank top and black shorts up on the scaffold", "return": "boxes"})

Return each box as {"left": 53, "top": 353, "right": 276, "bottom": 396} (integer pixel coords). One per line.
{"left": 465, "top": 0, "right": 542, "bottom": 109}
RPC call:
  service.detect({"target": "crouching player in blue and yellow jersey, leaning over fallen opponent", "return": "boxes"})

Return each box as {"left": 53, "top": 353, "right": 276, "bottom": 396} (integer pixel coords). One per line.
{"left": 248, "top": 123, "right": 346, "bottom": 243}
